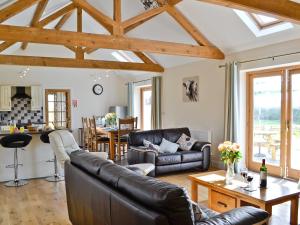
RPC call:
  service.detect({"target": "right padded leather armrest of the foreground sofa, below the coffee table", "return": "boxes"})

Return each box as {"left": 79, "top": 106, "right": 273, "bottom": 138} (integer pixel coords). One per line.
{"left": 196, "top": 206, "right": 269, "bottom": 225}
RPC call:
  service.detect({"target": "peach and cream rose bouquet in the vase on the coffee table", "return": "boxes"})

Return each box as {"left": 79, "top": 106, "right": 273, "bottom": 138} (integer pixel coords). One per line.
{"left": 218, "top": 141, "right": 242, "bottom": 164}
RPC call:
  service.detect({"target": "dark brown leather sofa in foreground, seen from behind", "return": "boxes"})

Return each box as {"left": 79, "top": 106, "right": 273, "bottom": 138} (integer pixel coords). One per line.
{"left": 65, "top": 151, "right": 268, "bottom": 225}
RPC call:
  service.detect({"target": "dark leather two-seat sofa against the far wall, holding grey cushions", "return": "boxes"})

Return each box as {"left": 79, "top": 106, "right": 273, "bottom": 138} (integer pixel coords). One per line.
{"left": 127, "top": 127, "right": 211, "bottom": 177}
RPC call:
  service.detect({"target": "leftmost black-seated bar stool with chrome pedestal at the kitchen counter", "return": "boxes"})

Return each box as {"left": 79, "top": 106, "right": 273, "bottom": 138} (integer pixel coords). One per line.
{"left": 0, "top": 134, "right": 32, "bottom": 187}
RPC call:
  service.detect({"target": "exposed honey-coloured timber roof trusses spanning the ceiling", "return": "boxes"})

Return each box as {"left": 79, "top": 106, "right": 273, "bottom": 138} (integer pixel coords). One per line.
{"left": 0, "top": 0, "right": 300, "bottom": 72}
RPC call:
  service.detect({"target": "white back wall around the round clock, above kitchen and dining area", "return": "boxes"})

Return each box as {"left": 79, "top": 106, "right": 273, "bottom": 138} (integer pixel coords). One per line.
{"left": 0, "top": 66, "right": 127, "bottom": 139}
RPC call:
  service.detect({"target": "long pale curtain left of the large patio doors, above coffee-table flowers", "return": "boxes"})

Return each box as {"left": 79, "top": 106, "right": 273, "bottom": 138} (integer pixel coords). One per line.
{"left": 224, "top": 62, "right": 240, "bottom": 142}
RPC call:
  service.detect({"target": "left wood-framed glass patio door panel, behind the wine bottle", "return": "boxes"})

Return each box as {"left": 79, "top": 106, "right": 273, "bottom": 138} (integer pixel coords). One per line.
{"left": 248, "top": 71, "right": 286, "bottom": 176}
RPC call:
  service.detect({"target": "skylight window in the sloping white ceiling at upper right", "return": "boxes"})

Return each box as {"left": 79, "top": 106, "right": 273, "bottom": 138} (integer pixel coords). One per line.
{"left": 234, "top": 9, "right": 294, "bottom": 37}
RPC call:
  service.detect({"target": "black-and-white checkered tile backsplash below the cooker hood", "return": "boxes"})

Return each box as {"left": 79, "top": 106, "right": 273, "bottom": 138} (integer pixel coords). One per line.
{"left": 1, "top": 98, "right": 44, "bottom": 124}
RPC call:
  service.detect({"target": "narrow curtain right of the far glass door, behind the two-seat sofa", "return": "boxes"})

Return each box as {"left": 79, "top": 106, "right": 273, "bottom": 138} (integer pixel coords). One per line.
{"left": 151, "top": 77, "right": 162, "bottom": 129}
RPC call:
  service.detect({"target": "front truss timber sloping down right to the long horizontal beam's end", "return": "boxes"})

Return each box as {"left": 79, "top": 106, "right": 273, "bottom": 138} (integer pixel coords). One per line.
{"left": 166, "top": 6, "right": 213, "bottom": 46}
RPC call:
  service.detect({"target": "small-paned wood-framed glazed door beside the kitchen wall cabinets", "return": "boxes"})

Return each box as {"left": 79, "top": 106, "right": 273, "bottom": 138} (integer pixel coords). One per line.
{"left": 45, "top": 89, "right": 71, "bottom": 128}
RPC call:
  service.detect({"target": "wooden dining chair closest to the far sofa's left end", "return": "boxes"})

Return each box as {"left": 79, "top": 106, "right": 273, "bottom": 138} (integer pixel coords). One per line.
{"left": 117, "top": 117, "right": 137, "bottom": 160}
